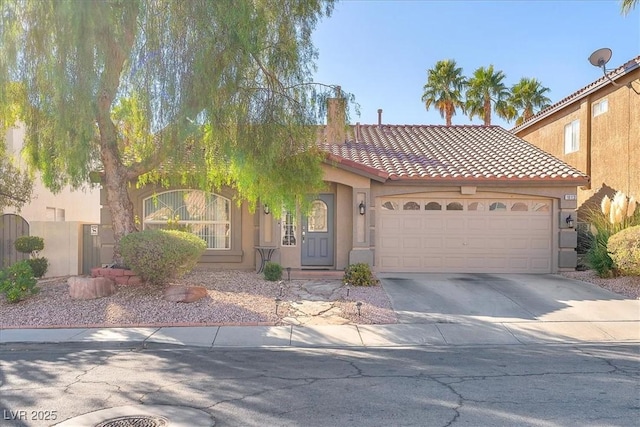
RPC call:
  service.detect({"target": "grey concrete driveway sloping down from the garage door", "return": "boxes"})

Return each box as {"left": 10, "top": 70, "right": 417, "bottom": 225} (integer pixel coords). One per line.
{"left": 378, "top": 273, "right": 640, "bottom": 324}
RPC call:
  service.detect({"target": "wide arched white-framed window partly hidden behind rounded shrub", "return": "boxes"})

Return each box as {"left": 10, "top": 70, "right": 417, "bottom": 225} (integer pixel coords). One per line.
{"left": 142, "top": 190, "right": 231, "bottom": 250}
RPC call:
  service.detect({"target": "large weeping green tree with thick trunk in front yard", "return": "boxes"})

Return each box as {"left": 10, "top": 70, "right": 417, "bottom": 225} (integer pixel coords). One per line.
{"left": 0, "top": 0, "right": 340, "bottom": 263}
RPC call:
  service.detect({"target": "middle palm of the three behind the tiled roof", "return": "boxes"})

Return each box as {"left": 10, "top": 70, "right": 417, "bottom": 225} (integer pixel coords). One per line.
{"left": 465, "top": 65, "right": 509, "bottom": 126}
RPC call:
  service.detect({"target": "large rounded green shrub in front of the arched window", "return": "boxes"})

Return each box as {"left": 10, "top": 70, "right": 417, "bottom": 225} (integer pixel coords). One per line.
{"left": 120, "top": 230, "right": 207, "bottom": 284}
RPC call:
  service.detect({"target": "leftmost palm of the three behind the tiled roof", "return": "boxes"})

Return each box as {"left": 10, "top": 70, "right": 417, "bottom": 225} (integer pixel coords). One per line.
{"left": 422, "top": 59, "right": 466, "bottom": 126}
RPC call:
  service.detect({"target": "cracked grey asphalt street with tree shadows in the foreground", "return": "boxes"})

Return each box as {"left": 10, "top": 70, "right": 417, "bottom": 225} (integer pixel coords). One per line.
{"left": 0, "top": 343, "right": 640, "bottom": 427}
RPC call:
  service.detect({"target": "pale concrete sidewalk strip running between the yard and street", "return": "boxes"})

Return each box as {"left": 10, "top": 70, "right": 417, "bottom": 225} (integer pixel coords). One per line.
{"left": 0, "top": 319, "right": 640, "bottom": 349}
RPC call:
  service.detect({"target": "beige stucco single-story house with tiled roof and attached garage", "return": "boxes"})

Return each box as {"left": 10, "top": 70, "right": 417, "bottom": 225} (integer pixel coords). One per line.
{"left": 101, "top": 100, "right": 589, "bottom": 273}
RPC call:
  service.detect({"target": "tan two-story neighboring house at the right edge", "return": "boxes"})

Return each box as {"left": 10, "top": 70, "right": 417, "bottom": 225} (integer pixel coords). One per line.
{"left": 512, "top": 56, "right": 640, "bottom": 220}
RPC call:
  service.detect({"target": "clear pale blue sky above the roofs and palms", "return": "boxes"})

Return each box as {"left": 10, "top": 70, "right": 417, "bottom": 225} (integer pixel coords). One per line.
{"left": 313, "top": 0, "right": 640, "bottom": 129}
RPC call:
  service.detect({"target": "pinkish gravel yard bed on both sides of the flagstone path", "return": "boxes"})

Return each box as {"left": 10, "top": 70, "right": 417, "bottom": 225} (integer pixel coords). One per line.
{"left": 0, "top": 270, "right": 396, "bottom": 328}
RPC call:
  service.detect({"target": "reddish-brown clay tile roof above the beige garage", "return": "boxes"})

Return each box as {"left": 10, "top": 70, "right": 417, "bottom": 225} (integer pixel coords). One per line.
{"left": 320, "top": 125, "right": 589, "bottom": 185}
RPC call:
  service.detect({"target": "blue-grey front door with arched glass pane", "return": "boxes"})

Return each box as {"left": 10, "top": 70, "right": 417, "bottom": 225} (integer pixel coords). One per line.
{"left": 301, "top": 194, "right": 334, "bottom": 267}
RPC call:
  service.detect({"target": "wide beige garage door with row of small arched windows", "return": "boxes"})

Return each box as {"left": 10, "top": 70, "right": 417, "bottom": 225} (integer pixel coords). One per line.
{"left": 376, "top": 197, "right": 553, "bottom": 273}
